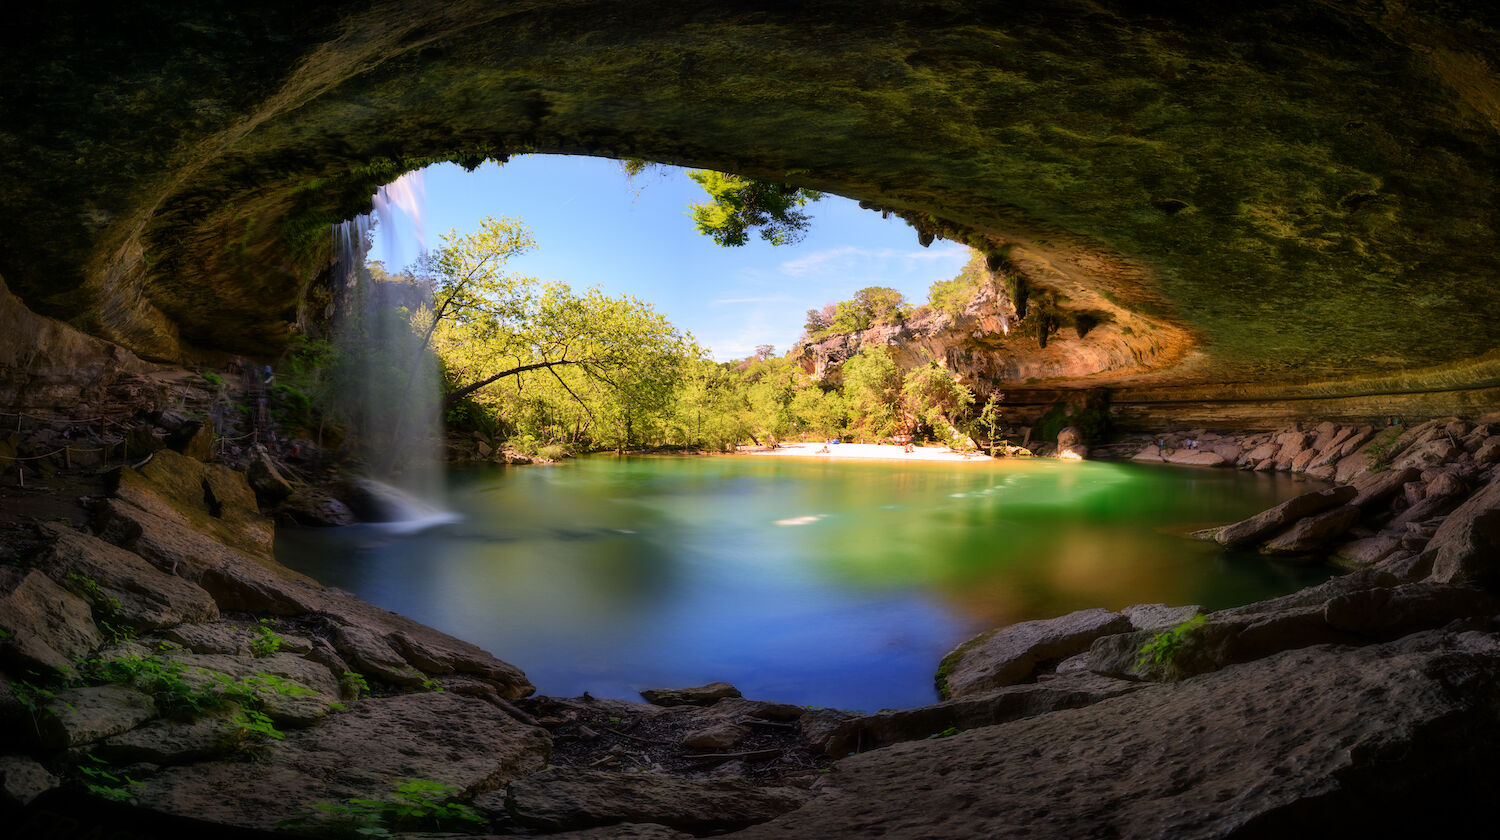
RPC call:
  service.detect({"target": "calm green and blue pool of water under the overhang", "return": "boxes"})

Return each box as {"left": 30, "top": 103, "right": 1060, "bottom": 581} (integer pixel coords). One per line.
{"left": 278, "top": 456, "right": 1328, "bottom": 710}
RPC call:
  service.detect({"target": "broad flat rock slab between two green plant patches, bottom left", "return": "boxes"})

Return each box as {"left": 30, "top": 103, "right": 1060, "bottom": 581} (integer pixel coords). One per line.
{"left": 138, "top": 692, "right": 552, "bottom": 830}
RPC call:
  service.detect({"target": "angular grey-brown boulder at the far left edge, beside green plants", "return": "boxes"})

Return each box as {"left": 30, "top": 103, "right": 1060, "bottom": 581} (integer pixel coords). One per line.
{"left": 0, "top": 566, "right": 104, "bottom": 674}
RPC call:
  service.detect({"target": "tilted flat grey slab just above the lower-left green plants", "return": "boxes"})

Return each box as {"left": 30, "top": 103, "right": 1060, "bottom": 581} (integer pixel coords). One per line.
{"left": 42, "top": 524, "right": 219, "bottom": 632}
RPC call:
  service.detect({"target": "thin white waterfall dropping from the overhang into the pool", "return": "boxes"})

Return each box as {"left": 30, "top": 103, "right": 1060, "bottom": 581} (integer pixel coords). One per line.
{"left": 333, "top": 173, "right": 452, "bottom": 530}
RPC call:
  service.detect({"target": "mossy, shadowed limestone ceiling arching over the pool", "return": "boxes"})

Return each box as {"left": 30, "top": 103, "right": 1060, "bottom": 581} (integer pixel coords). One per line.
{"left": 0, "top": 0, "right": 1500, "bottom": 386}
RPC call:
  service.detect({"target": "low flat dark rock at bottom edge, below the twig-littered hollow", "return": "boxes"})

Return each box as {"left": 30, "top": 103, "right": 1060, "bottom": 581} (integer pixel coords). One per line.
{"left": 506, "top": 768, "right": 810, "bottom": 834}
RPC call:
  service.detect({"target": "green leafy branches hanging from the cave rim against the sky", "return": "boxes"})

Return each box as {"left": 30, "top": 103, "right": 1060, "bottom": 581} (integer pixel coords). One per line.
{"left": 687, "top": 170, "right": 822, "bottom": 248}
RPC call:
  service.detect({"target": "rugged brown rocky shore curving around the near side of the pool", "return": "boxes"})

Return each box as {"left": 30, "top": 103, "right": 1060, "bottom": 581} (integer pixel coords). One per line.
{"left": 0, "top": 419, "right": 1500, "bottom": 839}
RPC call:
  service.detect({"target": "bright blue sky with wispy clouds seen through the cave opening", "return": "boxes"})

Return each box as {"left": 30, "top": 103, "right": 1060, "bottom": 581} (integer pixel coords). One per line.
{"left": 371, "top": 155, "right": 968, "bottom": 362}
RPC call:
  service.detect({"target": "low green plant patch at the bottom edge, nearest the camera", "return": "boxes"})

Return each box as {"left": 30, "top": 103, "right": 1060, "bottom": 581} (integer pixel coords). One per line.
{"left": 279, "top": 779, "right": 486, "bottom": 837}
